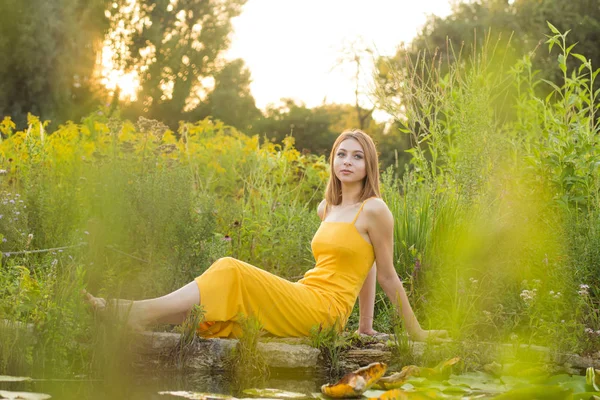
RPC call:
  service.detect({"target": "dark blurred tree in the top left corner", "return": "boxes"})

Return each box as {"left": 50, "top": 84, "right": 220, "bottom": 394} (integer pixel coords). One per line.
{"left": 0, "top": 0, "right": 108, "bottom": 126}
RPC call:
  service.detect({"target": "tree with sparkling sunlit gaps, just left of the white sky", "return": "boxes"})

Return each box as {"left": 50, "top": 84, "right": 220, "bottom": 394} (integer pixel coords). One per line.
{"left": 111, "top": 0, "right": 246, "bottom": 126}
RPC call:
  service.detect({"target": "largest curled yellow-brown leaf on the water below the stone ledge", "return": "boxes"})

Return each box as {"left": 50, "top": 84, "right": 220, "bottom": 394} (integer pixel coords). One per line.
{"left": 321, "top": 363, "right": 387, "bottom": 398}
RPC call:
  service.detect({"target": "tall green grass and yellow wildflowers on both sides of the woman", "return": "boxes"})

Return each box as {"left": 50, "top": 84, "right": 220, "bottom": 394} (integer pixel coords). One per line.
{"left": 0, "top": 22, "right": 600, "bottom": 374}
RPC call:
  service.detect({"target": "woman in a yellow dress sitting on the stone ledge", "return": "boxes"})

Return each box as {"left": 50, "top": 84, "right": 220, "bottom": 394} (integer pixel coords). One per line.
{"left": 86, "top": 130, "right": 446, "bottom": 340}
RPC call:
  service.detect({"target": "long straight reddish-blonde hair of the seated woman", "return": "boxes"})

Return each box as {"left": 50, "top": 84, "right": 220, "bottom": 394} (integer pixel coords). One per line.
{"left": 325, "top": 129, "right": 381, "bottom": 205}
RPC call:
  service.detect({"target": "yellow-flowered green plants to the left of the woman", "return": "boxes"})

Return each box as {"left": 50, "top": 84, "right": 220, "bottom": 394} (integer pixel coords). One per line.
{"left": 0, "top": 110, "right": 327, "bottom": 374}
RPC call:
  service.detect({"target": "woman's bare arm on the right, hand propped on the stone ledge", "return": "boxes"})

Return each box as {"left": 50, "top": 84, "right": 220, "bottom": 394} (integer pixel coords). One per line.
{"left": 364, "top": 199, "right": 445, "bottom": 340}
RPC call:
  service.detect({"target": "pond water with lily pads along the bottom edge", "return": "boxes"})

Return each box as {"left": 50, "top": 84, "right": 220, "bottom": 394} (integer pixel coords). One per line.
{"left": 0, "top": 367, "right": 600, "bottom": 400}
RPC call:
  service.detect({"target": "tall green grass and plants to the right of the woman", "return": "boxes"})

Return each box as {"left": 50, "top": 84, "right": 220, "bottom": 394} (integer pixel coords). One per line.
{"left": 380, "top": 25, "right": 600, "bottom": 351}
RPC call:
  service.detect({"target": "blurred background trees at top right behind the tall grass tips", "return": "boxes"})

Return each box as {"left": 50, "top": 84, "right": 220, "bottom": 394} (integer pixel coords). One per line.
{"left": 376, "top": 0, "right": 600, "bottom": 171}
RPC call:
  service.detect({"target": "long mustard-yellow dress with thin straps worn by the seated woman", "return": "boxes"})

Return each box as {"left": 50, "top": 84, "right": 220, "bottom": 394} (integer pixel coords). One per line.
{"left": 196, "top": 200, "right": 375, "bottom": 337}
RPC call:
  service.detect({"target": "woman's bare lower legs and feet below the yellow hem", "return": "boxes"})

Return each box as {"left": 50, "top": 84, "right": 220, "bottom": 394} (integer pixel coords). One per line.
{"left": 85, "top": 281, "right": 200, "bottom": 329}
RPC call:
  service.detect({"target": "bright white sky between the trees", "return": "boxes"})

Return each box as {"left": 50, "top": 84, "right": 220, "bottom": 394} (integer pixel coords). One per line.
{"left": 226, "top": 0, "right": 450, "bottom": 114}
